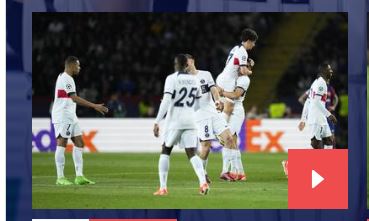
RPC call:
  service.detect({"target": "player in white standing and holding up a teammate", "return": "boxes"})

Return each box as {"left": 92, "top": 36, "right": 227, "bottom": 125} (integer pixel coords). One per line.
{"left": 218, "top": 59, "right": 254, "bottom": 181}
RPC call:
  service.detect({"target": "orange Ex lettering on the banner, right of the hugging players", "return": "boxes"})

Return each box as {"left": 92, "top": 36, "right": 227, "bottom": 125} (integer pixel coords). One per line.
{"left": 245, "top": 120, "right": 285, "bottom": 152}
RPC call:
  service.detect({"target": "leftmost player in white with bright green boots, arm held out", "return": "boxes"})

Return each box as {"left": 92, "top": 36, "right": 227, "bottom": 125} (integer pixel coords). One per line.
{"left": 51, "top": 56, "right": 108, "bottom": 185}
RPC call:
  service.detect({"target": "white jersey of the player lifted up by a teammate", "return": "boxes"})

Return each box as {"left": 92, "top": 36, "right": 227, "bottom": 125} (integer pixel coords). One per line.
{"left": 222, "top": 45, "right": 248, "bottom": 79}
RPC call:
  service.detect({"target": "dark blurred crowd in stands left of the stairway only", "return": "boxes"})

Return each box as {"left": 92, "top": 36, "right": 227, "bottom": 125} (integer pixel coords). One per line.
{"left": 33, "top": 13, "right": 283, "bottom": 117}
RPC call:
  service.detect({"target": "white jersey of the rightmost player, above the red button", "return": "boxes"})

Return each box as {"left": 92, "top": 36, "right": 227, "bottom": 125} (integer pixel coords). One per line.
{"left": 307, "top": 77, "right": 328, "bottom": 125}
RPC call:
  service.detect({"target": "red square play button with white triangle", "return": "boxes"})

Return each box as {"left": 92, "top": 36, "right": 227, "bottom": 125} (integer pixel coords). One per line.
{"left": 288, "top": 149, "right": 348, "bottom": 209}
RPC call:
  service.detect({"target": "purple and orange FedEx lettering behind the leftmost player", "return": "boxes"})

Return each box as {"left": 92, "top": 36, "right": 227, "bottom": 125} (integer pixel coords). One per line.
{"left": 32, "top": 122, "right": 97, "bottom": 152}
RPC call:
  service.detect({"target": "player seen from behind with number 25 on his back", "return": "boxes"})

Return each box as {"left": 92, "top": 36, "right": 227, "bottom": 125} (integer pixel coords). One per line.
{"left": 154, "top": 54, "right": 209, "bottom": 196}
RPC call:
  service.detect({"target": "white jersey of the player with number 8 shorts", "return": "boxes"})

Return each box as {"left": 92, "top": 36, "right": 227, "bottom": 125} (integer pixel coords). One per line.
{"left": 195, "top": 70, "right": 219, "bottom": 121}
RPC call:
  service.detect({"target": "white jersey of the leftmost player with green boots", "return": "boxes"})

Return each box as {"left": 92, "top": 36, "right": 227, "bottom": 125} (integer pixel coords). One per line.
{"left": 51, "top": 72, "right": 78, "bottom": 124}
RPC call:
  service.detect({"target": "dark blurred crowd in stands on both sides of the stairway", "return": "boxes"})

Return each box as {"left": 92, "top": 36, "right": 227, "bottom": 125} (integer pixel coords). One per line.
{"left": 32, "top": 13, "right": 347, "bottom": 138}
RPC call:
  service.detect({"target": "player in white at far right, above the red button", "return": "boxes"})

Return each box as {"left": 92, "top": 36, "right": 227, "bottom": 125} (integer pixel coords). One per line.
{"left": 299, "top": 63, "right": 337, "bottom": 149}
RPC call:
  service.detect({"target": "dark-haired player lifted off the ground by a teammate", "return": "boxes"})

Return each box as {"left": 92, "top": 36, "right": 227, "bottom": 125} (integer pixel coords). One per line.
{"left": 216, "top": 29, "right": 258, "bottom": 122}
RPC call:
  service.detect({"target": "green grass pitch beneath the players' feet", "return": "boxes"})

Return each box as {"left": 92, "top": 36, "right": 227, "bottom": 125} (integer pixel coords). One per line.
{"left": 32, "top": 153, "right": 287, "bottom": 209}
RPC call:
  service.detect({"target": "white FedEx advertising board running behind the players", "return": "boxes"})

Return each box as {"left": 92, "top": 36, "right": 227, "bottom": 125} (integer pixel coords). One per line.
{"left": 32, "top": 118, "right": 310, "bottom": 152}
